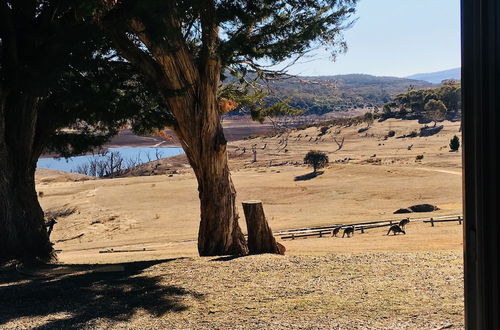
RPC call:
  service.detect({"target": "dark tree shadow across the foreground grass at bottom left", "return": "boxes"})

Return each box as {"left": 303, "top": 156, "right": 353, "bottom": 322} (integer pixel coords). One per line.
{"left": 0, "top": 259, "right": 202, "bottom": 329}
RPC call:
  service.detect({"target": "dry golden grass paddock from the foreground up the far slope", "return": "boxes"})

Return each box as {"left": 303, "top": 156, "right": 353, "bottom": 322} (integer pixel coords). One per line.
{"left": 0, "top": 119, "right": 463, "bottom": 329}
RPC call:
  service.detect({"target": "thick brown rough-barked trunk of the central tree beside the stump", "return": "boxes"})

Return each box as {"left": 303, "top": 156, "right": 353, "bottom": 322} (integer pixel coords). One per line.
{"left": 178, "top": 95, "right": 248, "bottom": 256}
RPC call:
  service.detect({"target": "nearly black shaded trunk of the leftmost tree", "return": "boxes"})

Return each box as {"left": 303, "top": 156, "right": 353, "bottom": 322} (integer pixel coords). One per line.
{"left": 0, "top": 95, "right": 53, "bottom": 260}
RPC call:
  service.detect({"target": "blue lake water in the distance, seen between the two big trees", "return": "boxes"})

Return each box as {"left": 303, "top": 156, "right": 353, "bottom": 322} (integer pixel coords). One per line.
{"left": 37, "top": 148, "right": 184, "bottom": 172}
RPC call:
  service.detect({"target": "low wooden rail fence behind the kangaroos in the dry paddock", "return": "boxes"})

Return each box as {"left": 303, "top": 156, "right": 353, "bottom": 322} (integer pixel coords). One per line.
{"left": 274, "top": 215, "right": 463, "bottom": 239}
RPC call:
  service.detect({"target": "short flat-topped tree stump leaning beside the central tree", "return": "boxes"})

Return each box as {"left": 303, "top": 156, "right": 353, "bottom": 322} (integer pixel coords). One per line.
{"left": 242, "top": 201, "right": 286, "bottom": 254}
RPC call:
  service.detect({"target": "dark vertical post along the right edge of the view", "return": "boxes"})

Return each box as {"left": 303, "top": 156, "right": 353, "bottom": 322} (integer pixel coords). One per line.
{"left": 462, "top": 0, "right": 500, "bottom": 329}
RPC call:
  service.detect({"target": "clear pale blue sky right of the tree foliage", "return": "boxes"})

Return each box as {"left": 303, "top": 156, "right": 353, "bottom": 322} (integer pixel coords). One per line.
{"left": 289, "top": 0, "right": 460, "bottom": 77}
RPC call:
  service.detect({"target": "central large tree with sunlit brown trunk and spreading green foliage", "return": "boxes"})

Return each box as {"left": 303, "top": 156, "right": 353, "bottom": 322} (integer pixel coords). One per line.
{"left": 95, "top": 0, "right": 356, "bottom": 256}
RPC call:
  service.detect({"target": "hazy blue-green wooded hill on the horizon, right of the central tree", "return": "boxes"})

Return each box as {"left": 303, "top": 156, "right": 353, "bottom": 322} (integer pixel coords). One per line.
{"left": 262, "top": 74, "right": 434, "bottom": 115}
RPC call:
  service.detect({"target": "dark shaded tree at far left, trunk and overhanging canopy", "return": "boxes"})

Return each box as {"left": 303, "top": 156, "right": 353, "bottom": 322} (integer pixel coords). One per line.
{"left": 0, "top": 0, "right": 162, "bottom": 260}
